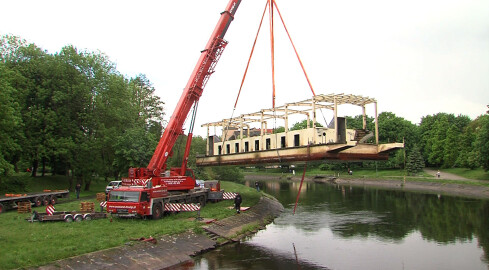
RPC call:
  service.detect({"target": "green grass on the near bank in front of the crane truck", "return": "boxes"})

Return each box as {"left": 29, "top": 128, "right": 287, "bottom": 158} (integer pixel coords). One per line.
{"left": 0, "top": 182, "right": 262, "bottom": 269}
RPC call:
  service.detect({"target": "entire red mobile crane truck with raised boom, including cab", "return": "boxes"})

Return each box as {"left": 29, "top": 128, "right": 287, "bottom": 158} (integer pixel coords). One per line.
{"left": 107, "top": 0, "right": 241, "bottom": 219}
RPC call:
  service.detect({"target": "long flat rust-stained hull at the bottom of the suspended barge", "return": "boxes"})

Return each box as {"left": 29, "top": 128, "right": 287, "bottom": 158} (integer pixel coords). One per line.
{"left": 197, "top": 143, "right": 404, "bottom": 167}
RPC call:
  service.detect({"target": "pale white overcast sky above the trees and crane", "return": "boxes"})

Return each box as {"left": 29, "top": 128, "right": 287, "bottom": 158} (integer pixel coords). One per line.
{"left": 0, "top": 0, "right": 489, "bottom": 136}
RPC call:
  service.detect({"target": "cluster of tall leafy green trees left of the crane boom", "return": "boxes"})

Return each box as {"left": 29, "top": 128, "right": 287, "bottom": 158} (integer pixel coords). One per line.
{"left": 0, "top": 36, "right": 164, "bottom": 189}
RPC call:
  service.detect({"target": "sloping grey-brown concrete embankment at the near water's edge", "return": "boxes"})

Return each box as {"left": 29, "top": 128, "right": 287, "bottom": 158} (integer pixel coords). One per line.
{"left": 36, "top": 197, "right": 284, "bottom": 269}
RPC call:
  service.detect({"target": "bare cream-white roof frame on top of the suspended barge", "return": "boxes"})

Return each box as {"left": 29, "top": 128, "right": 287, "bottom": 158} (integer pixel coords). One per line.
{"left": 202, "top": 93, "right": 379, "bottom": 143}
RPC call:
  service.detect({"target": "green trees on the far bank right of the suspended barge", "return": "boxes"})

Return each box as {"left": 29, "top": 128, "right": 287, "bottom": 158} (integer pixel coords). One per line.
{"left": 347, "top": 111, "right": 489, "bottom": 171}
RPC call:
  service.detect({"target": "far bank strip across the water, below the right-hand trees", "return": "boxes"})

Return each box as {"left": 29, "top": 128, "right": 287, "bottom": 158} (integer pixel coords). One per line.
{"left": 245, "top": 175, "right": 489, "bottom": 199}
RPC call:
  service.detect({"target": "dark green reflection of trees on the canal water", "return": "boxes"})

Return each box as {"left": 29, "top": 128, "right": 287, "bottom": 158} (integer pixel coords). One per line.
{"left": 252, "top": 182, "right": 489, "bottom": 244}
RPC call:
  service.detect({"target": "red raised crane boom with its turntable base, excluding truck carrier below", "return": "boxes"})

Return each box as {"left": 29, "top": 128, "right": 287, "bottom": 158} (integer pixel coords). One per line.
{"left": 123, "top": 0, "right": 241, "bottom": 190}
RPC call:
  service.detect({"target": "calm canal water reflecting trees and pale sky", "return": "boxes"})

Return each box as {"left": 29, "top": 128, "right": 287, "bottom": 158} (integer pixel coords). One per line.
{"left": 184, "top": 178, "right": 489, "bottom": 269}
